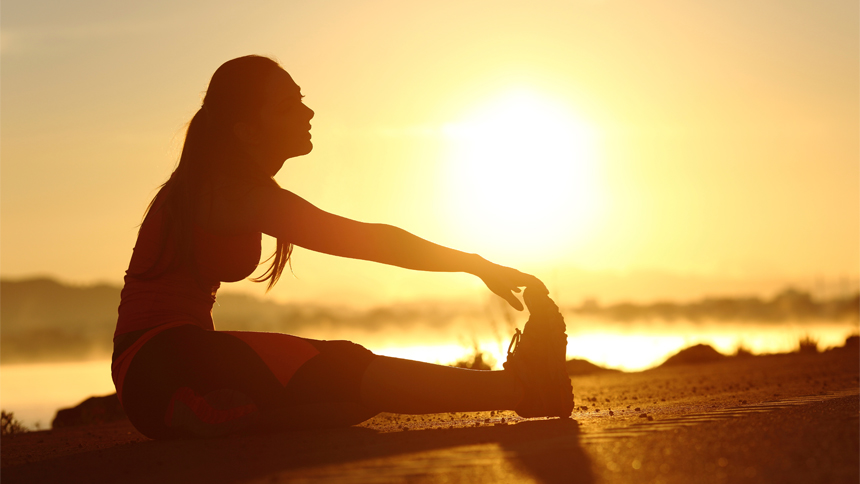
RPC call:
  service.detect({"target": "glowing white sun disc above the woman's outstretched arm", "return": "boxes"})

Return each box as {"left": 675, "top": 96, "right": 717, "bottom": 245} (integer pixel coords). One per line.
{"left": 444, "top": 90, "right": 600, "bottom": 259}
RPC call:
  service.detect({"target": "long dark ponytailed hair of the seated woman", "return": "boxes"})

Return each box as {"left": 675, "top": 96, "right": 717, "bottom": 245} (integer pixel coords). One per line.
{"left": 139, "top": 55, "right": 293, "bottom": 291}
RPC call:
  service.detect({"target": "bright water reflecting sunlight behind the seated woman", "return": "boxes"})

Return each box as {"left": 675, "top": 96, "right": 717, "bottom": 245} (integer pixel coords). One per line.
{"left": 0, "top": 319, "right": 858, "bottom": 429}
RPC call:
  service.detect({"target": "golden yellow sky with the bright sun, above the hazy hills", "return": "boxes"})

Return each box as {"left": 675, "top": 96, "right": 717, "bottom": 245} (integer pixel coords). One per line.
{"left": 0, "top": 0, "right": 860, "bottom": 305}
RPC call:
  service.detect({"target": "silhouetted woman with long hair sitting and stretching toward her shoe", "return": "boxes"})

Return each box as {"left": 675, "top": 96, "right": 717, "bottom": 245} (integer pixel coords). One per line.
{"left": 112, "top": 56, "right": 573, "bottom": 438}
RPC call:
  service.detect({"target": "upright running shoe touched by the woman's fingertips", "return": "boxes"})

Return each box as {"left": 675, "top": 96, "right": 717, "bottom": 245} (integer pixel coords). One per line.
{"left": 504, "top": 288, "right": 573, "bottom": 418}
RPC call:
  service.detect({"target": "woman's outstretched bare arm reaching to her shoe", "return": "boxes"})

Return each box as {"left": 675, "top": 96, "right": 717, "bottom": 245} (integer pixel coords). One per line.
{"left": 237, "top": 183, "right": 545, "bottom": 310}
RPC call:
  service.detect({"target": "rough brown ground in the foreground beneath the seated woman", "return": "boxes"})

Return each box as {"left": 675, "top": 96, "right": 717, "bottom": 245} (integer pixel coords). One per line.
{"left": 0, "top": 349, "right": 860, "bottom": 484}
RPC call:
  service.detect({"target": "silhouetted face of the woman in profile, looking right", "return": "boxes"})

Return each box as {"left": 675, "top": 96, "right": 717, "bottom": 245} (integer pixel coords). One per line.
{"left": 242, "top": 69, "right": 314, "bottom": 175}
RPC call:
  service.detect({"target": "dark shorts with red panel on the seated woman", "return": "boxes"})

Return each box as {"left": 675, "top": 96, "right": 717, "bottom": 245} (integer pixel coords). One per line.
{"left": 115, "top": 324, "right": 376, "bottom": 438}
